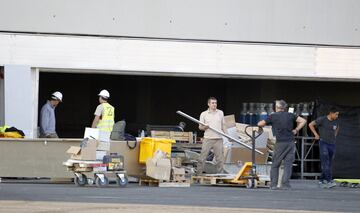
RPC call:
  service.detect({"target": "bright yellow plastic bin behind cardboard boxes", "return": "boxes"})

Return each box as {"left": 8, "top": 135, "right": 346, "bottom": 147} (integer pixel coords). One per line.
{"left": 139, "top": 138, "right": 176, "bottom": 163}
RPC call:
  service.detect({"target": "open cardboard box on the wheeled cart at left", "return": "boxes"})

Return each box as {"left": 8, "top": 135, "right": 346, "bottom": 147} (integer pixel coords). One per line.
{"left": 66, "top": 140, "right": 97, "bottom": 160}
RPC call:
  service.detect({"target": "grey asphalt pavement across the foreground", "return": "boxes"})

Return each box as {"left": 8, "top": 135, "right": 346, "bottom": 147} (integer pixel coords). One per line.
{"left": 0, "top": 180, "right": 360, "bottom": 212}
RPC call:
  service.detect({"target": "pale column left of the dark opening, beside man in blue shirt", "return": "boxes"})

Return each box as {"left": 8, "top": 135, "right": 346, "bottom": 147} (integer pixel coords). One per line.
{"left": 4, "top": 65, "right": 39, "bottom": 138}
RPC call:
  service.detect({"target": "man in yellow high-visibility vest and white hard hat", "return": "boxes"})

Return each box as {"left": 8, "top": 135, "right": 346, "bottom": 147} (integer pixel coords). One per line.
{"left": 91, "top": 89, "right": 115, "bottom": 133}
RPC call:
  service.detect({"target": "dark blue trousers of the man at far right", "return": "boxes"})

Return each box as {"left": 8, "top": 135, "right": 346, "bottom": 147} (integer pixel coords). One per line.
{"left": 319, "top": 139, "right": 335, "bottom": 182}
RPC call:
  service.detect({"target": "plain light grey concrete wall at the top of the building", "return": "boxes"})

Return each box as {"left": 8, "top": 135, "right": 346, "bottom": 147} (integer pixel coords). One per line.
{"left": 0, "top": 0, "right": 360, "bottom": 46}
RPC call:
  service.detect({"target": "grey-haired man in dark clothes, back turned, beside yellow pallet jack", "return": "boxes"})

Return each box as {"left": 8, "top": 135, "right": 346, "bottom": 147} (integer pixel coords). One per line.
{"left": 258, "top": 100, "right": 306, "bottom": 189}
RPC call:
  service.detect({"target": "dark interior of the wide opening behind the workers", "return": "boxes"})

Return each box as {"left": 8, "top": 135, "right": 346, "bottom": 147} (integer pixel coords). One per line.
{"left": 39, "top": 72, "right": 360, "bottom": 137}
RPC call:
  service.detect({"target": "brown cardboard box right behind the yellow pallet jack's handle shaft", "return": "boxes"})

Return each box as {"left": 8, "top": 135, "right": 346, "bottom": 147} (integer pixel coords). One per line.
{"left": 231, "top": 147, "right": 268, "bottom": 164}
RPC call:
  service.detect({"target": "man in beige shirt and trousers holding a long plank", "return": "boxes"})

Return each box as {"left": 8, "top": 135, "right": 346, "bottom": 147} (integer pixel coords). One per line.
{"left": 197, "top": 97, "right": 227, "bottom": 175}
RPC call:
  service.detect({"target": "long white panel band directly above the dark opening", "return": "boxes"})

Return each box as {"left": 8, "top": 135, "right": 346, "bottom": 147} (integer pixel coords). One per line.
{"left": 0, "top": 34, "right": 360, "bottom": 80}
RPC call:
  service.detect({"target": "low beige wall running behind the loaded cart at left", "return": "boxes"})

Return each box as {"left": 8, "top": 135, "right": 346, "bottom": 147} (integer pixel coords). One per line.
{"left": 0, "top": 138, "right": 143, "bottom": 178}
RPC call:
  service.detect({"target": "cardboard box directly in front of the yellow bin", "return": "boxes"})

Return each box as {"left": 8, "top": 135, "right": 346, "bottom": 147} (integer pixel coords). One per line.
{"left": 146, "top": 158, "right": 171, "bottom": 181}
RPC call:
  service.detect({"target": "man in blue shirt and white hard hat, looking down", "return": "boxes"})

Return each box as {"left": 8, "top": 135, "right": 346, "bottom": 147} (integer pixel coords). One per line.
{"left": 40, "top": 91, "right": 63, "bottom": 138}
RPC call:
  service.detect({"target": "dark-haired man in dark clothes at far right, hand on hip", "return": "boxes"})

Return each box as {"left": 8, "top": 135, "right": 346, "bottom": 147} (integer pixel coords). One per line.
{"left": 309, "top": 107, "right": 339, "bottom": 188}
